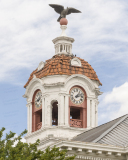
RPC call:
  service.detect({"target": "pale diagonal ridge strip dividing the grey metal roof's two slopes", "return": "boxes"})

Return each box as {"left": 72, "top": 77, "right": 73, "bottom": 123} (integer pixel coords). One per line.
{"left": 92, "top": 114, "right": 128, "bottom": 143}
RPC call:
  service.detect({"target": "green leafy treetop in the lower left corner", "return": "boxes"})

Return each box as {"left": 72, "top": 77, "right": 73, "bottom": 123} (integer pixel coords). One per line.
{"left": 0, "top": 128, "right": 75, "bottom": 160}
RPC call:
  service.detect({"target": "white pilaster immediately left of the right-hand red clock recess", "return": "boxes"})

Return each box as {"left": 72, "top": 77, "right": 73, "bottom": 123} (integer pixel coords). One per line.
{"left": 65, "top": 95, "right": 69, "bottom": 127}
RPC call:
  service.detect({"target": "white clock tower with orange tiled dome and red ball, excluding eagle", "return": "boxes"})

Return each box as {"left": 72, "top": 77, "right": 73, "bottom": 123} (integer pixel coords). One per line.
{"left": 24, "top": 18, "right": 102, "bottom": 145}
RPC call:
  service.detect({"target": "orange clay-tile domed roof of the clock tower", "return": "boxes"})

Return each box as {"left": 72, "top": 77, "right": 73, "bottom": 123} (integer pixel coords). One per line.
{"left": 24, "top": 54, "right": 102, "bottom": 88}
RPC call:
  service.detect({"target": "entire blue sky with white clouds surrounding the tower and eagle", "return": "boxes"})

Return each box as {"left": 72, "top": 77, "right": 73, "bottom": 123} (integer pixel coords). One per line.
{"left": 0, "top": 0, "right": 128, "bottom": 134}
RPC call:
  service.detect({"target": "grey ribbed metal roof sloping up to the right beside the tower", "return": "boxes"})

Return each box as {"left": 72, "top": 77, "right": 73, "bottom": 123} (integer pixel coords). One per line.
{"left": 72, "top": 114, "right": 128, "bottom": 146}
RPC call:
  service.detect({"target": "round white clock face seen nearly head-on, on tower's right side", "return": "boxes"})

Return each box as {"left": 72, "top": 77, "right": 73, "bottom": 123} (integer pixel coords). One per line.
{"left": 70, "top": 87, "right": 84, "bottom": 105}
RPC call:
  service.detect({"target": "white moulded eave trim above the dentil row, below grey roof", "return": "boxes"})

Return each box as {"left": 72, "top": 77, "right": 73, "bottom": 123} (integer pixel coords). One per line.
{"left": 39, "top": 137, "right": 128, "bottom": 156}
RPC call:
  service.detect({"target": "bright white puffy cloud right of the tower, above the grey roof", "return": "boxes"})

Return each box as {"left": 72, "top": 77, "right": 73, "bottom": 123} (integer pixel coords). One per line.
{"left": 99, "top": 82, "right": 128, "bottom": 124}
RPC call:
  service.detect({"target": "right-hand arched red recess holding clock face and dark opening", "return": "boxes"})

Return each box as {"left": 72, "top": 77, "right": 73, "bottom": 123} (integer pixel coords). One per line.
{"left": 69, "top": 86, "right": 87, "bottom": 128}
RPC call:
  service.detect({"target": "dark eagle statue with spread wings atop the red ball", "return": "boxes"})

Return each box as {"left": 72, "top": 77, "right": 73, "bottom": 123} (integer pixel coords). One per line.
{"left": 49, "top": 4, "right": 81, "bottom": 22}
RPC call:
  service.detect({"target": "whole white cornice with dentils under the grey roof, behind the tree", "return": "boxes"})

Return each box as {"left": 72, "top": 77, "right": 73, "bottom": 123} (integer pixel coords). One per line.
{"left": 40, "top": 137, "right": 128, "bottom": 160}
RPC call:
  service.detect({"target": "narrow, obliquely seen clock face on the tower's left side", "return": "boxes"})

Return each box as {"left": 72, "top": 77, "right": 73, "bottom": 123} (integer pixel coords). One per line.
{"left": 35, "top": 91, "right": 42, "bottom": 108}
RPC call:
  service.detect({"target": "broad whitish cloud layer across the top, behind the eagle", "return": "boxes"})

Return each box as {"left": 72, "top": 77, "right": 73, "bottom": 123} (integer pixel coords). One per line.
{"left": 0, "top": 0, "right": 128, "bottom": 82}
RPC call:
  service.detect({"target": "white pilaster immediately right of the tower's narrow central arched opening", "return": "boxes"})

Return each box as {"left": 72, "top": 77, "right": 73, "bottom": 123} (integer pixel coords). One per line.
{"left": 59, "top": 95, "right": 64, "bottom": 126}
